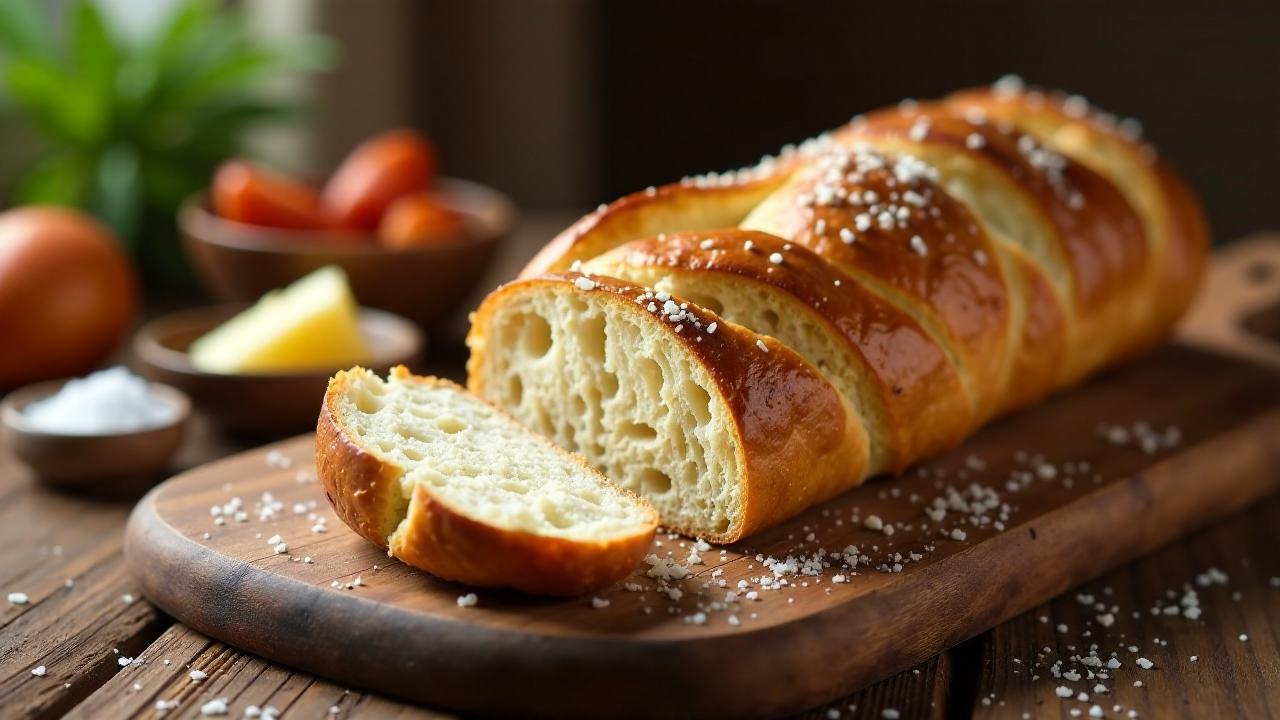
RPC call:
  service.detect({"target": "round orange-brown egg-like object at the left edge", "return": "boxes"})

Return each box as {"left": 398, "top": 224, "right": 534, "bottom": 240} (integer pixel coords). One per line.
{"left": 0, "top": 206, "right": 138, "bottom": 387}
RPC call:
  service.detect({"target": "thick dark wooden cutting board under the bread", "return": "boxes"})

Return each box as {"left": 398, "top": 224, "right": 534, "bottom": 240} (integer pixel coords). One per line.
{"left": 125, "top": 346, "right": 1280, "bottom": 716}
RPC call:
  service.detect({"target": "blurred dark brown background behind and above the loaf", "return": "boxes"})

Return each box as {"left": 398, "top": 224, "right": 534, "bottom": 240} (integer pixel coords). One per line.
{"left": 280, "top": 0, "right": 1280, "bottom": 242}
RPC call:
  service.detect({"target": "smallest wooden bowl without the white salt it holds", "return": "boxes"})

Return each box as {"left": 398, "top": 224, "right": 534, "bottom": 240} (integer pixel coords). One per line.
{"left": 0, "top": 379, "right": 191, "bottom": 496}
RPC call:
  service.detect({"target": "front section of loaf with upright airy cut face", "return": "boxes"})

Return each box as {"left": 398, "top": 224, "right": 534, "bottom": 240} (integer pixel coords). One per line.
{"left": 467, "top": 273, "right": 868, "bottom": 542}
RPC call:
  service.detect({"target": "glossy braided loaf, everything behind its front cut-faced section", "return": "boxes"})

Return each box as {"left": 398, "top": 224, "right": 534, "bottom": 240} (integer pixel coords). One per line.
{"left": 472, "top": 79, "right": 1210, "bottom": 537}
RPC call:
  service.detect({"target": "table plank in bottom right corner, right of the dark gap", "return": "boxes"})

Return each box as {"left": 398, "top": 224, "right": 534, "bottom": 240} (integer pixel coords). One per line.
{"left": 970, "top": 496, "right": 1280, "bottom": 719}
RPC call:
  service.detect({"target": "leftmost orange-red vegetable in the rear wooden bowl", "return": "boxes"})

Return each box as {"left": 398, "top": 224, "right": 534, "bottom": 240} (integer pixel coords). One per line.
{"left": 210, "top": 160, "right": 325, "bottom": 229}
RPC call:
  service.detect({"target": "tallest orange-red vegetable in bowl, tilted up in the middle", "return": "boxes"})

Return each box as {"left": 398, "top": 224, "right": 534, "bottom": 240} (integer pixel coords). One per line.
{"left": 323, "top": 129, "right": 436, "bottom": 231}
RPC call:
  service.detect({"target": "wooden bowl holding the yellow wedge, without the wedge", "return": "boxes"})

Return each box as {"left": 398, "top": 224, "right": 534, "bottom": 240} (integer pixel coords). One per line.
{"left": 133, "top": 304, "right": 424, "bottom": 437}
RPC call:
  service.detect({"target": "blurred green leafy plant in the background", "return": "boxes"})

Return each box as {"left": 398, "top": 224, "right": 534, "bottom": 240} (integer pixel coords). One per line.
{"left": 0, "top": 0, "right": 334, "bottom": 286}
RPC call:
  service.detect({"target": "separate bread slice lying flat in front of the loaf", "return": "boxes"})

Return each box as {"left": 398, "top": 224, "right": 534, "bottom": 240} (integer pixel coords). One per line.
{"left": 316, "top": 366, "right": 658, "bottom": 596}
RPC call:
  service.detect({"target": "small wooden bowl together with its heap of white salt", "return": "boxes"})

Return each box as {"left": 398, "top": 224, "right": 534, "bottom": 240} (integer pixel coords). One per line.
{"left": 0, "top": 368, "right": 191, "bottom": 495}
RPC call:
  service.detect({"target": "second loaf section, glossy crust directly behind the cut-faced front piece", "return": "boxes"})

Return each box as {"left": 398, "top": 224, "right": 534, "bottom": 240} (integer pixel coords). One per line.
{"left": 582, "top": 229, "right": 974, "bottom": 475}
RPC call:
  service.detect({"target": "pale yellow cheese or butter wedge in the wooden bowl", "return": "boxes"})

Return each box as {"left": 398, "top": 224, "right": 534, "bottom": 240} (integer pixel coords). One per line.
{"left": 189, "top": 265, "right": 371, "bottom": 373}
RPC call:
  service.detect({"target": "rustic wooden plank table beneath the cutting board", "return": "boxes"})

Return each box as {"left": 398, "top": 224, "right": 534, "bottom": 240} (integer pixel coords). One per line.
{"left": 0, "top": 225, "right": 1280, "bottom": 719}
